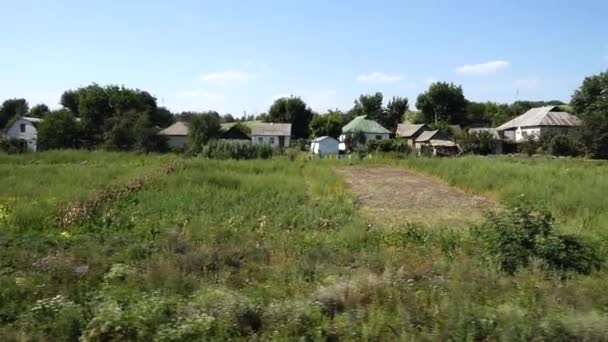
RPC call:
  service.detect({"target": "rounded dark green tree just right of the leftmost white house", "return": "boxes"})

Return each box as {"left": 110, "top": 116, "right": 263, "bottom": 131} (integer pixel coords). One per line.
{"left": 38, "top": 109, "right": 81, "bottom": 150}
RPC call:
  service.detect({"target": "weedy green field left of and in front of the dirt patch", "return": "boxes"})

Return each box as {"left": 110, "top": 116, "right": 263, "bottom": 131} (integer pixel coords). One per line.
{"left": 0, "top": 152, "right": 608, "bottom": 341}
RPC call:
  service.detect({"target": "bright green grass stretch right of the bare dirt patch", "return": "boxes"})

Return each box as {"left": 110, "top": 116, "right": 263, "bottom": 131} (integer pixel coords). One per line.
{"left": 403, "top": 156, "right": 608, "bottom": 239}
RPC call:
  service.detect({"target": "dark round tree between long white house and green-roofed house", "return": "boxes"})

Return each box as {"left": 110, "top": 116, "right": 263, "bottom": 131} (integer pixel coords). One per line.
{"left": 265, "top": 96, "right": 313, "bottom": 138}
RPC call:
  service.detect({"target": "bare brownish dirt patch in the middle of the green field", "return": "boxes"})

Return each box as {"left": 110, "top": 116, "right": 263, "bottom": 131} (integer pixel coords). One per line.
{"left": 336, "top": 166, "right": 495, "bottom": 226}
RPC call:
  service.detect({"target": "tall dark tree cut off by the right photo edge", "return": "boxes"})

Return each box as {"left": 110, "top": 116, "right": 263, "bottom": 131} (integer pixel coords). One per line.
{"left": 570, "top": 71, "right": 608, "bottom": 159}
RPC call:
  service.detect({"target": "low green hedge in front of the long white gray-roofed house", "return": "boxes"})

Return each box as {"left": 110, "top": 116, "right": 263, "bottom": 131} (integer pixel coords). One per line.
{"left": 202, "top": 140, "right": 273, "bottom": 160}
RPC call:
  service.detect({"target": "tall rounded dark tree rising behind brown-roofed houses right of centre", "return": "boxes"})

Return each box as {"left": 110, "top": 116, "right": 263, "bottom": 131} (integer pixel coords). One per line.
{"left": 416, "top": 82, "right": 467, "bottom": 124}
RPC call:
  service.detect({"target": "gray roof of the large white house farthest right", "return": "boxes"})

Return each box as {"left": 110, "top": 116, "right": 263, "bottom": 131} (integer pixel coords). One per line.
{"left": 496, "top": 106, "right": 581, "bottom": 131}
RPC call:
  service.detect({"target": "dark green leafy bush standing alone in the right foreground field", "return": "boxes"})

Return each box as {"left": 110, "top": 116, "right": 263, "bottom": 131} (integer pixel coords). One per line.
{"left": 474, "top": 208, "right": 601, "bottom": 274}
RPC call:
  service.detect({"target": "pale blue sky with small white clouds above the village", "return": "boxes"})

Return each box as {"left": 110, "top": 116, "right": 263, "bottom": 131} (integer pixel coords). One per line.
{"left": 0, "top": 0, "right": 608, "bottom": 115}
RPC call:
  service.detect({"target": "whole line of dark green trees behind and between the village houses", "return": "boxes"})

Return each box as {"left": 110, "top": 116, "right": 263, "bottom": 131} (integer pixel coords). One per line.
{"left": 0, "top": 72, "right": 608, "bottom": 158}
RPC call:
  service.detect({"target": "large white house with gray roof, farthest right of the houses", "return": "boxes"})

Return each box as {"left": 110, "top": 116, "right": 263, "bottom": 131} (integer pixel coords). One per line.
{"left": 496, "top": 106, "right": 581, "bottom": 142}
